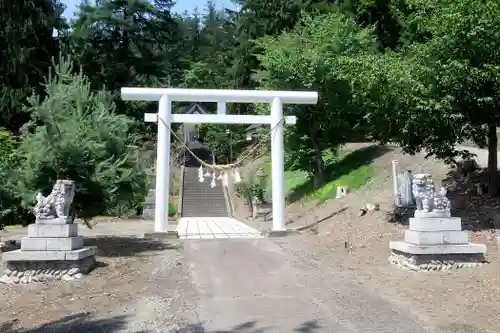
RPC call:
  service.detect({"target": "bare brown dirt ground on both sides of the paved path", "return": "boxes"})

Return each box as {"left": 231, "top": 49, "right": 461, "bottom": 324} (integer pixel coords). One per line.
{"left": 0, "top": 144, "right": 500, "bottom": 333}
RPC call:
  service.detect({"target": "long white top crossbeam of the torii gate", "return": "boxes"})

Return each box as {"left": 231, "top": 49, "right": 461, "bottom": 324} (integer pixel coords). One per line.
{"left": 121, "top": 87, "right": 318, "bottom": 104}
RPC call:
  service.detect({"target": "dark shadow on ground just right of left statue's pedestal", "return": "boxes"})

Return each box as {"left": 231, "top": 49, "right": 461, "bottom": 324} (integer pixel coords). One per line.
{"left": 85, "top": 236, "right": 178, "bottom": 258}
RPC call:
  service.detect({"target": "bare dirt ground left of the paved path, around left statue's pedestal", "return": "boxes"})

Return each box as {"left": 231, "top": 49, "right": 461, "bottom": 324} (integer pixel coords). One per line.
{"left": 0, "top": 219, "right": 186, "bottom": 333}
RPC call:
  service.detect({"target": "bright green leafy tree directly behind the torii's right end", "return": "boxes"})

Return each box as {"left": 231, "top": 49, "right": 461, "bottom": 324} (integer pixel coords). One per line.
{"left": 256, "top": 12, "right": 375, "bottom": 186}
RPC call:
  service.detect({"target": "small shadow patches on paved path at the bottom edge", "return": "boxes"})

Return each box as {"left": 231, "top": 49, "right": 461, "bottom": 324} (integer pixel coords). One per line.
{"left": 176, "top": 320, "right": 323, "bottom": 333}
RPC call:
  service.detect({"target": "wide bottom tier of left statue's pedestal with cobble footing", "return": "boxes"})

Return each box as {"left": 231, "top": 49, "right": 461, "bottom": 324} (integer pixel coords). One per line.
{"left": 0, "top": 247, "right": 97, "bottom": 284}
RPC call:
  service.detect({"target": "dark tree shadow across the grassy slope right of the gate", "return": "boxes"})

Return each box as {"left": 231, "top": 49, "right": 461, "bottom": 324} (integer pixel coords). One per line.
{"left": 287, "top": 145, "right": 390, "bottom": 204}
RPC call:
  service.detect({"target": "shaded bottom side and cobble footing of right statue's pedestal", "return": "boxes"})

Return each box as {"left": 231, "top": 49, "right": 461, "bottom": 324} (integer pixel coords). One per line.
{"left": 389, "top": 250, "right": 486, "bottom": 272}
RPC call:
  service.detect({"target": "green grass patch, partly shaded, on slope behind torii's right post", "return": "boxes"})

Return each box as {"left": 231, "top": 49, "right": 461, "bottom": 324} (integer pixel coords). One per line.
{"left": 261, "top": 146, "right": 387, "bottom": 204}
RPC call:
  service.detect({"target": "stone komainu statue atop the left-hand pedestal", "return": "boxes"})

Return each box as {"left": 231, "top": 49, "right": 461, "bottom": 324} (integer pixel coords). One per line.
{"left": 33, "top": 180, "right": 75, "bottom": 222}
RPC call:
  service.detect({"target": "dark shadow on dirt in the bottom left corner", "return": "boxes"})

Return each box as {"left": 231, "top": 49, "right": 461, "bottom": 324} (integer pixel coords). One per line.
{"left": 0, "top": 312, "right": 147, "bottom": 333}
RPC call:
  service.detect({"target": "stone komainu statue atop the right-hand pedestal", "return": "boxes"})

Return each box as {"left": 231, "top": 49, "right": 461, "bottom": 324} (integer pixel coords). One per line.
{"left": 412, "top": 174, "right": 451, "bottom": 216}
